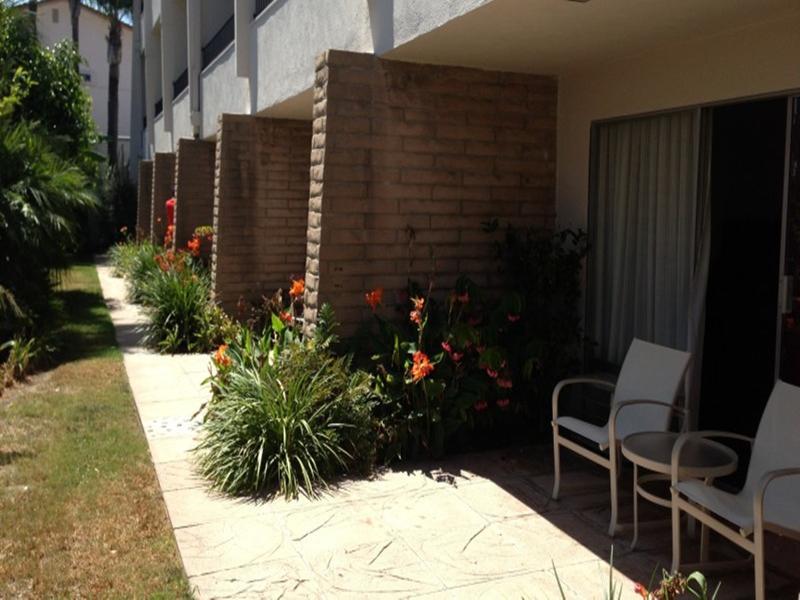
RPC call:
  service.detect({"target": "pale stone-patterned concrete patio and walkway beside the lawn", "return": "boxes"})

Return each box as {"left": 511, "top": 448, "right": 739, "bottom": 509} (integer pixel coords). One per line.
{"left": 92, "top": 264, "right": 796, "bottom": 599}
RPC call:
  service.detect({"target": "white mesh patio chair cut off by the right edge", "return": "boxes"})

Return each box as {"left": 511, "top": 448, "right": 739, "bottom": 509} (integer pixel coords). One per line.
{"left": 671, "top": 381, "right": 800, "bottom": 600}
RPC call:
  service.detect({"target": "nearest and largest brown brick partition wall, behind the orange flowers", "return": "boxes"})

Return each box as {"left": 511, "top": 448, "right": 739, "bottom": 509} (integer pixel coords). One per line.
{"left": 305, "top": 50, "right": 557, "bottom": 332}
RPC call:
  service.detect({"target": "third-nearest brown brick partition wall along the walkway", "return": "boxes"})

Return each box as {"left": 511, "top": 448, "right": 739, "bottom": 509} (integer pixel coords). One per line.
{"left": 175, "top": 139, "right": 216, "bottom": 248}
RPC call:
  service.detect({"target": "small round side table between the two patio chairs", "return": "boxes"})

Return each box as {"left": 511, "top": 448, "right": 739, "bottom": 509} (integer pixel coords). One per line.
{"left": 622, "top": 431, "right": 739, "bottom": 548}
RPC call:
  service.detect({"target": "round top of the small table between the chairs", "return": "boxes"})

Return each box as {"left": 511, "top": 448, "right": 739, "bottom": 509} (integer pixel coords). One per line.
{"left": 622, "top": 431, "right": 739, "bottom": 479}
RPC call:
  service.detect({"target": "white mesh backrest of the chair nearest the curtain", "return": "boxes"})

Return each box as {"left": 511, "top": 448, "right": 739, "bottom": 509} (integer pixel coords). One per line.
{"left": 614, "top": 338, "right": 691, "bottom": 440}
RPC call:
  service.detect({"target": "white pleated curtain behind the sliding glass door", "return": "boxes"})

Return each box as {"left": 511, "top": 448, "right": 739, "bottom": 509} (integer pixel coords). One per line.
{"left": 587, "top": 110, "right": 708, "bottom": 364}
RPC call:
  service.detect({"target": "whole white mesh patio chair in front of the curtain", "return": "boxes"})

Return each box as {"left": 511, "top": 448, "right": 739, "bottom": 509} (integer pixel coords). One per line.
{"left": 553, "top": 339, "right": 691, "bottom": 536}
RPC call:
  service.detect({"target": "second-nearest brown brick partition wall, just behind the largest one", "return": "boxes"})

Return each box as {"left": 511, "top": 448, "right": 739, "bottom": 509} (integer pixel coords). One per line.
{"left": 212, "top": 115, "right": 311, "bottom": 311}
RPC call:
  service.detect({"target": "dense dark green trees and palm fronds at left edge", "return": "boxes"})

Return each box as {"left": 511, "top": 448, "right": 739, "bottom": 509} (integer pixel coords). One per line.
{"left": 0, "top": 0, "right": 96, "bottom": 337}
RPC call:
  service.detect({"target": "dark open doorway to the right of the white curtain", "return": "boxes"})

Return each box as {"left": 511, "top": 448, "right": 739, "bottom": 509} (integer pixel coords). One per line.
{"left": 699, "top": 98, "right": 787, "bottom": 435}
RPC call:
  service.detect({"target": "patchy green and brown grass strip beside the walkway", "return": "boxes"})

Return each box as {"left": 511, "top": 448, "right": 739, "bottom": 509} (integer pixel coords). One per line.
{"left": 0, "top": 264, "right": 191, "bottom": 598}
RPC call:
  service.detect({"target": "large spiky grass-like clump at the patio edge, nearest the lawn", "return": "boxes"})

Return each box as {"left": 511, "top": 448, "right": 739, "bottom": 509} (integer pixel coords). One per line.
{"left": 197, "top": 319, "right": 375, "bottom": 498}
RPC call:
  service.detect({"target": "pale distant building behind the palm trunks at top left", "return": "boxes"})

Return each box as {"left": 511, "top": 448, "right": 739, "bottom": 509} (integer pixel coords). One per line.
{"left": 36, "top": 0, "right": 131, "bottom": 159}
